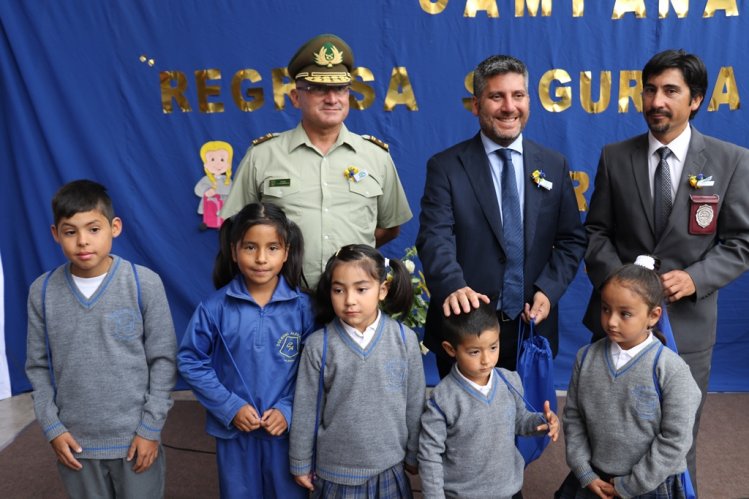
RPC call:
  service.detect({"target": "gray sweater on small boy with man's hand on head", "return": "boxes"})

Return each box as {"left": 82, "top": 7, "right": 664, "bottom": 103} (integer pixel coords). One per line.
{"left": 419, "top": 365, "right": 546, "bottom": 499}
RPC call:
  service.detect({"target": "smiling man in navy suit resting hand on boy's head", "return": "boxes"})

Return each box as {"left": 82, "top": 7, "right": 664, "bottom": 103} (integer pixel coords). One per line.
{"left": 416, "top": 55, "right": 585, "bottom": 377}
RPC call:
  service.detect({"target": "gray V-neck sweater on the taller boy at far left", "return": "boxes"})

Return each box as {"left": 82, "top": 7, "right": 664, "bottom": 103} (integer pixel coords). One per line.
{"left": 26, "top": 256, "right": 177, "bottom": 459}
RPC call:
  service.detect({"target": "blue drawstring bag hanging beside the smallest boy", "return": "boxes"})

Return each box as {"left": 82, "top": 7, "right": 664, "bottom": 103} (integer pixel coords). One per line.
{"left": 515, "top": 321, "right": 557, "bottom": 466}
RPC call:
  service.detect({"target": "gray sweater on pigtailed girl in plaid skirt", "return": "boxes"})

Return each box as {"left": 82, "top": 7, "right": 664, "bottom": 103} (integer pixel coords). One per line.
{"left": 289, "top": 314, "right": 425, "bottom": 485}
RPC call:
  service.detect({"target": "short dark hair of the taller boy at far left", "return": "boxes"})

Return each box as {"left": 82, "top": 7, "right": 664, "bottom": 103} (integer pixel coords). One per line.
{"left": 52, "top": 179, "right": 114, "bottom": 226}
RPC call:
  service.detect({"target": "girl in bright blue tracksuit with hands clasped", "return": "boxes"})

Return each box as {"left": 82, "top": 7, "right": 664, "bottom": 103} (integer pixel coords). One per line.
{"left": 178, "top": 203, "right": 315, "bottom": 498}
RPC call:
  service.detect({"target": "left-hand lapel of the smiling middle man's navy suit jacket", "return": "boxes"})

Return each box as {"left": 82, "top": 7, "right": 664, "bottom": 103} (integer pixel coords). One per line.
{"left": 459, "top": 134, "right": 504, "bottom": 248}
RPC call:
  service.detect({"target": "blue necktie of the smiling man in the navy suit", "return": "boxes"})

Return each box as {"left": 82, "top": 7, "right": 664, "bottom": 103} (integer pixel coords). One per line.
{"left": 497, "top": 149, "right": 524, "bottom": 319}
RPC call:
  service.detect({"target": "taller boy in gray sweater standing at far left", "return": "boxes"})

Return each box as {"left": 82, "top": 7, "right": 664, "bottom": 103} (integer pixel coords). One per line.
{"left": 26, "top": 180, "right": 176, "bottom": 497}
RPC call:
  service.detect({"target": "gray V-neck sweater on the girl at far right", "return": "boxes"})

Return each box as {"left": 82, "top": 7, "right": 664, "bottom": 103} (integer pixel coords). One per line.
{"left": 564, "top": 338, "right": 701, "bottom": 499}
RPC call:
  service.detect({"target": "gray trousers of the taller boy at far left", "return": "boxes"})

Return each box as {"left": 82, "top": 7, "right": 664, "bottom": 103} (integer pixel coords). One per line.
{"left": 57, "top": 446, "right": 166, "bottom": 499}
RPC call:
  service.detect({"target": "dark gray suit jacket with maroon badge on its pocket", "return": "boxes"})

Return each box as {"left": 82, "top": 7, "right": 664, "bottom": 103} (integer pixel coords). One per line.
{"left": 584, "top": 127, "right": 749, "bottom": 353}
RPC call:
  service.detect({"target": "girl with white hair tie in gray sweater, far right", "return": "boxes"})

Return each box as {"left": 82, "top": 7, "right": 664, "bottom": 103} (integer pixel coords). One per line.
{"left": 555, "top": 258, "right": 701, "bottom": 499}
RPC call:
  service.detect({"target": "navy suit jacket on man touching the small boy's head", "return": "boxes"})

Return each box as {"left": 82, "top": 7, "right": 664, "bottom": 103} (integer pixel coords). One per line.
{"left": 416, "top": 134, "right": 585, "bottom": 354}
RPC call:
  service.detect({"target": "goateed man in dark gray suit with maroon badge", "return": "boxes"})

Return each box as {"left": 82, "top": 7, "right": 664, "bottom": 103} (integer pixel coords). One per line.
{"left": 584, "top": 50, "right": 749, "bottom": 494}
